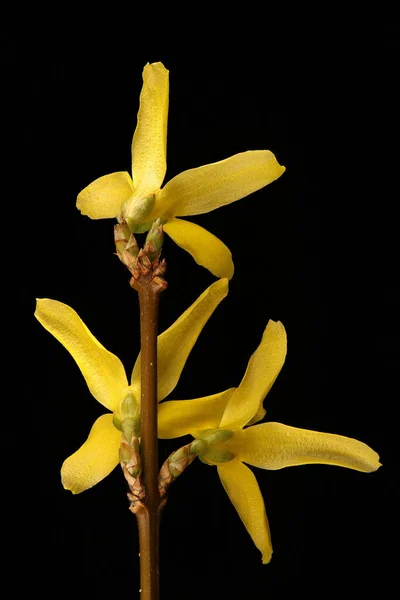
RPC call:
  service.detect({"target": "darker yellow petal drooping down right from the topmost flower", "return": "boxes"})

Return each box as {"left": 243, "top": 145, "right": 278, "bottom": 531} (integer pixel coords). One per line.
{"left": 163, "top": 219, "right": 234, "bottom": 279}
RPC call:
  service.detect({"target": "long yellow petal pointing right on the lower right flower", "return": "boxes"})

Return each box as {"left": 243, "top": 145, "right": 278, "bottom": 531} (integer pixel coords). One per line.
{"left": 232, "top": 423, "right": 381, "bottom": 473}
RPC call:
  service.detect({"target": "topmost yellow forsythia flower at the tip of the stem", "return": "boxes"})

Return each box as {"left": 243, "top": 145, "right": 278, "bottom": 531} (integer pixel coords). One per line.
{"left": 77, "top": 63, "right": 285, "bottom": 279}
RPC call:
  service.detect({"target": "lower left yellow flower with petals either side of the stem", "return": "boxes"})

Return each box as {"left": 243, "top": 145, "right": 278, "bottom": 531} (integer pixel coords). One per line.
{"left": 35, "top": 279, "right": 228, "bottom": 494}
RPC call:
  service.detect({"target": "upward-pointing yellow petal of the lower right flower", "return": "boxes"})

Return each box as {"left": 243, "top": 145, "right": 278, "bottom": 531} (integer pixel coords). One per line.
{"left": 221, "top": 321, "right": 287, "bottom": 429}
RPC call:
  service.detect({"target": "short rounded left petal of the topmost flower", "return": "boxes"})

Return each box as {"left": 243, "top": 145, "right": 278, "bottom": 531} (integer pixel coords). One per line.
{"left": 76, "top": 171, "right": 133, "bottom": 219}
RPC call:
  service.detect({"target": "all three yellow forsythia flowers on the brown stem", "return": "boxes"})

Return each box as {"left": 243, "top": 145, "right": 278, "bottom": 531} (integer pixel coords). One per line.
{"left": 35, "top": 63, "right": 380, "bottom": 563}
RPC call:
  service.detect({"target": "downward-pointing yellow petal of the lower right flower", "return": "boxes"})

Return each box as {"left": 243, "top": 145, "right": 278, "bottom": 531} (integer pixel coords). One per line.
{"left": 217, "top": 461, "right": 272, "bottom": 564}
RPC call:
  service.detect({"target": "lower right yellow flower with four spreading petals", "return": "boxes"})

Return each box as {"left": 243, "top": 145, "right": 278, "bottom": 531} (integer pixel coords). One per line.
{"left": 159, "top": 321, "right": 380, "bottom": 563}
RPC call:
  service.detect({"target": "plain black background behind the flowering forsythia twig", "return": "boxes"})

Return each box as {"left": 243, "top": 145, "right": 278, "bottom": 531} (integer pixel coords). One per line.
{"left": 2, "top": 14, "right": 399, "bottom": 600}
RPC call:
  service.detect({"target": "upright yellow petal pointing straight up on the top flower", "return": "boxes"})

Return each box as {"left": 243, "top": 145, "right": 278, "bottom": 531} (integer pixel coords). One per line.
{"left": 132, "top": 62, "right": 169, "bottom": 198}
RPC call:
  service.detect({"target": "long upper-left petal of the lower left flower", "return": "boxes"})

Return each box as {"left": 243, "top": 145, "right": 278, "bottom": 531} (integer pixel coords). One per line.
{"left": 35, "top": 298, "right": 128, "bottom": 410}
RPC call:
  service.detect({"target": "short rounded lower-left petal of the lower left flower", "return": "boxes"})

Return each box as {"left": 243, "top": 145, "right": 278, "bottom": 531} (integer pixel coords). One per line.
{"left": 61, "top": 414, "right": 121, "bottom": 494}
